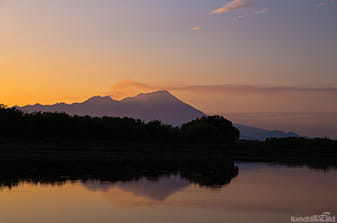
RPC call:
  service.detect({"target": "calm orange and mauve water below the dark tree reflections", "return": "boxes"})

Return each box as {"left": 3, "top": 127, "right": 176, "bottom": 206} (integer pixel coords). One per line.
{"left": 0, "top": 163, "right": 337, "bottom": 223}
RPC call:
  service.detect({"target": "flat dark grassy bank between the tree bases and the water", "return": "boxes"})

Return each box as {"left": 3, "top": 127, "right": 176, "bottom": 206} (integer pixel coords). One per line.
{"left": 0, "top": 138, "right": 337, "bottom": 163}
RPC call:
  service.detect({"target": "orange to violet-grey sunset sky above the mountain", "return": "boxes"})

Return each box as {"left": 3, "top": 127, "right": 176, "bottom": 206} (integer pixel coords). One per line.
{"left": 0, "top": 0, "right": 337, "bottom": 138}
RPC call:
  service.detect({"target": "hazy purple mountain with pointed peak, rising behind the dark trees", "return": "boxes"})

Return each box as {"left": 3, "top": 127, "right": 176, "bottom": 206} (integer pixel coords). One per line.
{"left": 17, "top": 90, "right": 298, "bottom": 140}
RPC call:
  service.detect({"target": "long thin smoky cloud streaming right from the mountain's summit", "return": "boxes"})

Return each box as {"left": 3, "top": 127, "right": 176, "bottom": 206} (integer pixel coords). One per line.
{"left": 106, "top": 80, "right": 337, "bottom": 98}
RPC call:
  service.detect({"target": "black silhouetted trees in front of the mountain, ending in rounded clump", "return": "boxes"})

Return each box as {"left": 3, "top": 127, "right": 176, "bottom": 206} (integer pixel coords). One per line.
{"left": 0, "top": 105, "right": 240, "bottom": 144}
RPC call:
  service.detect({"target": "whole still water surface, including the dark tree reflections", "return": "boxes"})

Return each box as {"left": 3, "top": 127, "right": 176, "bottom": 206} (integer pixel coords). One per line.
{"left": 0, "top": 160, "right": 337, "bottom": 223}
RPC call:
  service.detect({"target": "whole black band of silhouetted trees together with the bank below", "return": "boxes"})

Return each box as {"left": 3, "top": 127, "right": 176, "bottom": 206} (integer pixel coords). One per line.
{"left": 0, "top": 103, "right": 337, "bottom": 170}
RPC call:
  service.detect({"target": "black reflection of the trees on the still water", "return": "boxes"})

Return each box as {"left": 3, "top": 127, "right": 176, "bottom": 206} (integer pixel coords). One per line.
{"left": 0, "top": 159, "right": 239, "bottom": 189}
